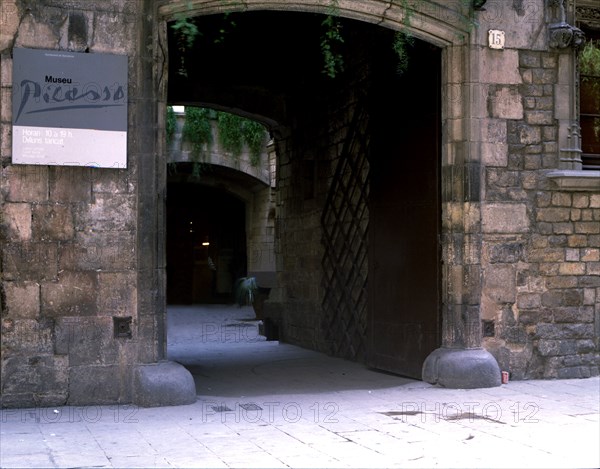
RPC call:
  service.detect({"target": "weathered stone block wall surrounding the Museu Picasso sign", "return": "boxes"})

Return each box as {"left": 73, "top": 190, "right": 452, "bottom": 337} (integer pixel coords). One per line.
{"left": 0, "top": 0, "right": 158, "bottom": 406}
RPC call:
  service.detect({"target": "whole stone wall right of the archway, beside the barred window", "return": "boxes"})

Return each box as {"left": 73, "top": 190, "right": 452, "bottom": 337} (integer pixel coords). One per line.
{"left": 474, "top": 3, "right": 600, "bottom": 379}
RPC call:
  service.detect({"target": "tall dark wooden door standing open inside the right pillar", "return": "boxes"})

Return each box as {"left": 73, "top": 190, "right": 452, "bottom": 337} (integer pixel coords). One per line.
{"left": 367, "top": 45, "right": 441, "bottom": 379}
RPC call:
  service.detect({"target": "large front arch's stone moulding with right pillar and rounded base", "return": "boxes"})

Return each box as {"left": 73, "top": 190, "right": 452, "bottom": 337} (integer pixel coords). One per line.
{"left": 146, "top": 0, "right": 499, "bottom": 387}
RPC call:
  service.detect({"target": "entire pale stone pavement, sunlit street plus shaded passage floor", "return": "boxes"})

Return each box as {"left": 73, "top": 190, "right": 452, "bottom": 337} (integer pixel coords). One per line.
{"left": 0, "top": 307, "right": 600, "bottom": 468}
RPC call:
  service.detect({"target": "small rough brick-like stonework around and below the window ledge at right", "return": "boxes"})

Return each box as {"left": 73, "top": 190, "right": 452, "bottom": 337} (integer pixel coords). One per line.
{"left": 482, "top": 51, "right": 600, "bottom": 379}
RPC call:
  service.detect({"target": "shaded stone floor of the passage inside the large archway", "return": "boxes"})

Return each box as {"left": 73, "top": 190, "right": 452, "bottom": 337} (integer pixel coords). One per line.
{"left": 167, "top": 305, "right": 420, "bottom": 397}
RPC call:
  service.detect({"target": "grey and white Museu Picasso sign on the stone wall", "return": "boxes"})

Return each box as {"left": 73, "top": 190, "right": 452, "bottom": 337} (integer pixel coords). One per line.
{"left": 12, "top": 48, "right": 127, "bottom": 168}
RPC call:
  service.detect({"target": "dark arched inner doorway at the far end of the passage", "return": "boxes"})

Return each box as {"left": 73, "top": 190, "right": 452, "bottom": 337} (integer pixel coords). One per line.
{"left": 166, "top": 182, "right": 246, "bottom": 305}
